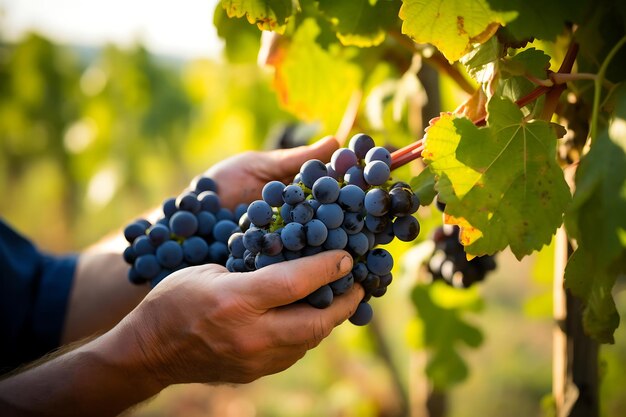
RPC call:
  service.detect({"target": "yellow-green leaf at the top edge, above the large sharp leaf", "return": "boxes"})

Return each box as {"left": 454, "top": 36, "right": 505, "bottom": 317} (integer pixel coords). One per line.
{"left": 400, "top": 0, "right": 517, "bottom": 62}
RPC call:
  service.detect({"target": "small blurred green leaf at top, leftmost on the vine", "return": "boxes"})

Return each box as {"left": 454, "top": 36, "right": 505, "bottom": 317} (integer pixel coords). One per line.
{"left": 213, "top": 4, "right": 261, "bottom": 62}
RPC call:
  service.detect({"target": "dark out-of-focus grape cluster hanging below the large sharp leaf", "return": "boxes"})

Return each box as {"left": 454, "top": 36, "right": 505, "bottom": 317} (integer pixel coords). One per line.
{"left": 428, "top": 225, "right": 496, "bottom": 288}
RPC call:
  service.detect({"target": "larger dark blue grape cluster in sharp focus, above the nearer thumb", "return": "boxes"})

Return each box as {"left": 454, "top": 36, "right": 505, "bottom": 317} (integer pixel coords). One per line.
{"left": 226, "top": 134, "right": 420, "bottom": 325}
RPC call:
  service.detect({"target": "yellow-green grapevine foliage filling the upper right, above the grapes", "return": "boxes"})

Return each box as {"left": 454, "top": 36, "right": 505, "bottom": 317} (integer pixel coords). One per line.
{"left": 215, "top": 0, "right": 626, "bottom": 354}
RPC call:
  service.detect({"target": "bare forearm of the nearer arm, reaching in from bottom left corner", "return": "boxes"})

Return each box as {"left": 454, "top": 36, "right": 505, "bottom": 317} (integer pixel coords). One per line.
{"left": 0, "top": 323, "right": 163, "bottom": 417}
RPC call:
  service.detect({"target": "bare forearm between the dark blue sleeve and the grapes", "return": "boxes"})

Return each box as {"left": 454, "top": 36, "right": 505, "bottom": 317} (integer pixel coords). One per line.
{"left": 61, "top": 232, "right": 150, "bottom": 344}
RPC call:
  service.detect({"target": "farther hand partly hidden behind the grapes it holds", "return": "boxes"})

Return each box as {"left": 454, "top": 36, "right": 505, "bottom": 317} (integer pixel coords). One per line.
{"left": 205, "top": 136, "right": 339, "bottom": 209}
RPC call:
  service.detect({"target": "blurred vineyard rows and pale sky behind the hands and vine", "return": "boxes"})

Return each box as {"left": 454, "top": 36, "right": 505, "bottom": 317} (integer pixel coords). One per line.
{"left": 0, "top": 0, "right": 626, "bottom": 417}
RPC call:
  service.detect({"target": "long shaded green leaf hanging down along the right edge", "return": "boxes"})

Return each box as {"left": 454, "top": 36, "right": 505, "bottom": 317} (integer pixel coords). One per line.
{"left": 565, "top": 88, "right": 626, "bottom": 343}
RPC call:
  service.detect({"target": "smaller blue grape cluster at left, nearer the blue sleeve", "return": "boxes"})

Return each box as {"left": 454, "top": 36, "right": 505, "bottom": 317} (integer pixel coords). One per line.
{"left": 124, "top": 176, "right": 248, "bottom": 287}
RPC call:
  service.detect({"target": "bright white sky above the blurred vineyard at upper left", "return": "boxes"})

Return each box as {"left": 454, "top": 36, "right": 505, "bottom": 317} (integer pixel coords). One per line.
{"left": 0, "top": 0, "right": 222, "bottom": 59}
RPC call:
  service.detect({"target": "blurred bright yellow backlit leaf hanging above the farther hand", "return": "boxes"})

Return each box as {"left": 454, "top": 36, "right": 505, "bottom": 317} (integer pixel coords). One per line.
{"left": 273, "top": 18, "right": 362, "bottom": 131}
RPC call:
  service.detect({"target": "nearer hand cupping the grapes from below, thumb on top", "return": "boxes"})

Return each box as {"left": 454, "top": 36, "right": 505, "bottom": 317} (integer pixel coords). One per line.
{"left": 125, "top": 250, "right": 363, "bottom": 387}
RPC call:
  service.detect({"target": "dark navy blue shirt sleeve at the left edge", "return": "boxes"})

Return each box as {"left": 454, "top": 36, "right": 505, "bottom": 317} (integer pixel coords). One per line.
{"left": 0, "top": 219, "right": 77, "bottom": 373}
